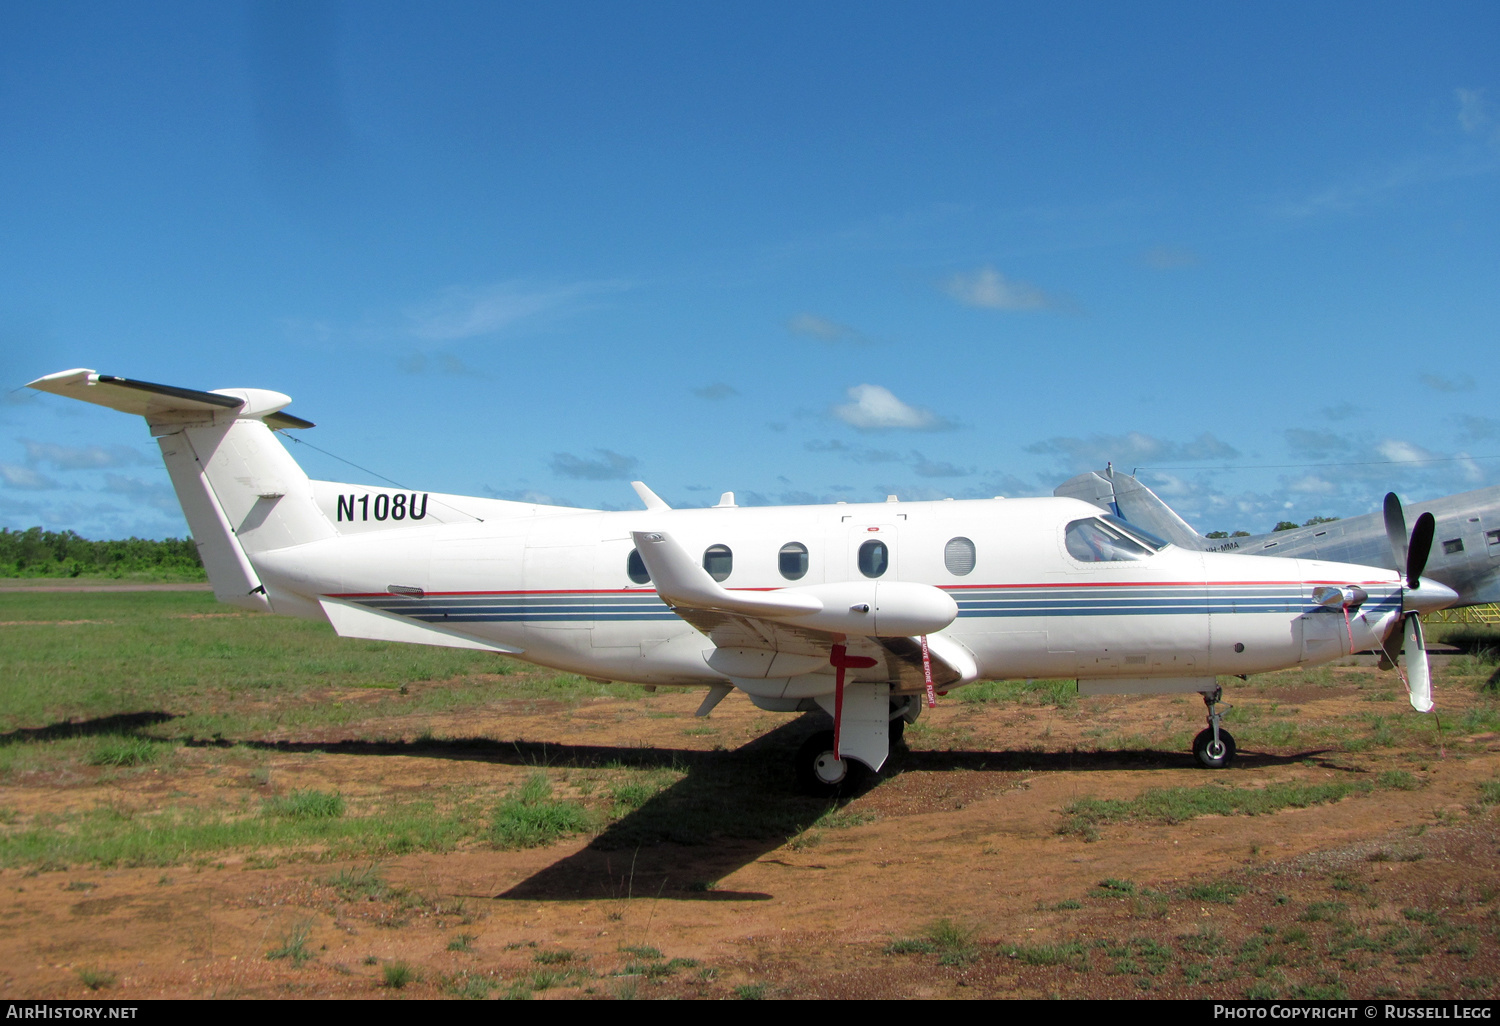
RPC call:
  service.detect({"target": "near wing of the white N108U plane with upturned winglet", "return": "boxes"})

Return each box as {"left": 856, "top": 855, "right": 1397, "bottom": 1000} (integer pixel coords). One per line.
{"left": 636, "top": 533, "right": 978, "bottom": 693}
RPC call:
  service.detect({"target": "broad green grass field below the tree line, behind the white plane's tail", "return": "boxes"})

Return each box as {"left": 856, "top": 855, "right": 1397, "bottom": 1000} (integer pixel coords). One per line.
{"left": 0, "top": 591, "right": 644, "bottom": 747}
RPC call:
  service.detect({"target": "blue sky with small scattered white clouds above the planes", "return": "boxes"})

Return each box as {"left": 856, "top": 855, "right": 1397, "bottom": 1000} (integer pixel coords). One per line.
{"left": 0, "top": 0, "right": 1500, "bottom": 537}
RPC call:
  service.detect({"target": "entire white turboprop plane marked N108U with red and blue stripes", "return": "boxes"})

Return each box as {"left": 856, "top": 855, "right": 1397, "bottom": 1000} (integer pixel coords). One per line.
{"left": 20, "top": 371, "right": 1457, "bottom": 795}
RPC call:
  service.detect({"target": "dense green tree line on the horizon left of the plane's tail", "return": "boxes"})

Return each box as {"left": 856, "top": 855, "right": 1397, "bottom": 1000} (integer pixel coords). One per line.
{"left": 0, "top": 528, "right": 204, "bottom": 581}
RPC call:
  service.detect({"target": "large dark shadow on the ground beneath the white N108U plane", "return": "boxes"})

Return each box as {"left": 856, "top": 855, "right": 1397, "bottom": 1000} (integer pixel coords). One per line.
{"left": 172, "top": 714, "right": 1337, "bottom": 902}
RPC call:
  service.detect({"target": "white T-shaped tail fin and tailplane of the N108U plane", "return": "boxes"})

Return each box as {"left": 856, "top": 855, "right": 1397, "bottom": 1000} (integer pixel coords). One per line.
{"left": 30, "top": 369, "right": 335, "bottom": 611}
